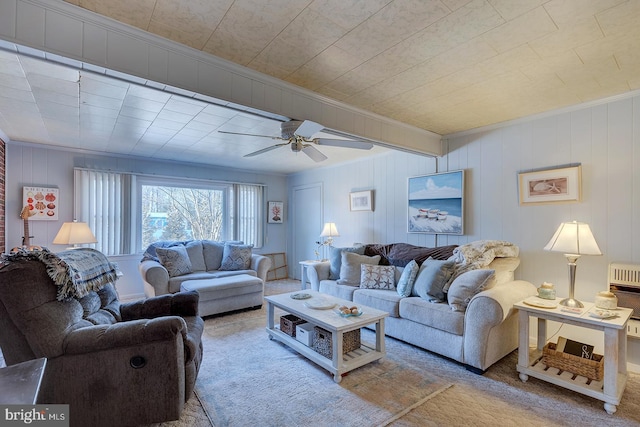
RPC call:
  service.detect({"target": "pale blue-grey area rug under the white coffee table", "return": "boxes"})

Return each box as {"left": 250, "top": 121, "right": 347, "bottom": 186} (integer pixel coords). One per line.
{"left": 196, "top": 310, "right": 450, "bottom": 426}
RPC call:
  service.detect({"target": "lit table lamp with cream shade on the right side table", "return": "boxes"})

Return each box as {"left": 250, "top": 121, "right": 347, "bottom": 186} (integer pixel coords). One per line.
{"left": 544, "top": 221, "right": 602, "bottom": 308}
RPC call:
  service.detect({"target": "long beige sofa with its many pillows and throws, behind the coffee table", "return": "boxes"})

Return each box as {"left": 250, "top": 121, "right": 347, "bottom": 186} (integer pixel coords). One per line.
{"left": 308, "top": 241, "right": 536, "bottom": 373}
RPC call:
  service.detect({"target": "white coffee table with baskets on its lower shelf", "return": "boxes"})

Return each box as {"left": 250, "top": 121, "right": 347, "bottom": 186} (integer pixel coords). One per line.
{"left": 265, "top": 290, "right": 389, "bottom": 383}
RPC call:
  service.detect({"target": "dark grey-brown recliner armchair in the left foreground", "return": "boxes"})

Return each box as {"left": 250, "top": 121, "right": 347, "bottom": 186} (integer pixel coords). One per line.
{"left": 0, "top": 251, "right": 204, "bottom": 426}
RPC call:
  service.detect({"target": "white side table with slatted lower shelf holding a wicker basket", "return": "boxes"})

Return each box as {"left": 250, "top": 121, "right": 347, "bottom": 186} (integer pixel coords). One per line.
{"left": 514, "top": 298, "right": 633, "bottom": 414}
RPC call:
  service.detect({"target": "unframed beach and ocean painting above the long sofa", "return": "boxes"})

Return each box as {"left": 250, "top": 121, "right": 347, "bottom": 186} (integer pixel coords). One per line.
{"left": 407, "top": 170, "right": 464, "bottom": 235}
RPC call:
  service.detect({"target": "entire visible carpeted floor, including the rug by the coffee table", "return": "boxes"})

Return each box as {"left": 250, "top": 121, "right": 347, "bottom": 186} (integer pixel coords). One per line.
{"left": 152, "top": 280, "right": 640, "bottom": 427}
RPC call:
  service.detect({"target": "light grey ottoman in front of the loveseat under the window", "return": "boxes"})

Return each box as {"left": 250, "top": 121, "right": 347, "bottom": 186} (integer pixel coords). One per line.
{"left": 180, "top": 274, "right": 264, "bottom": 316}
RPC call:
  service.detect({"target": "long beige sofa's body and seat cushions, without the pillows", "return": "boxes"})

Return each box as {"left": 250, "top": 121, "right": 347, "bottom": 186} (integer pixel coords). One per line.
{"left": 308, "top": 244, "right": 536, "bottom": 373}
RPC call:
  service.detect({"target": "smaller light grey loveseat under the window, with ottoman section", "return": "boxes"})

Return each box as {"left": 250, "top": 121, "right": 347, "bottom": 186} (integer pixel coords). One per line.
{"left": 139, "top": 240, "right": 271, "bottom": 316}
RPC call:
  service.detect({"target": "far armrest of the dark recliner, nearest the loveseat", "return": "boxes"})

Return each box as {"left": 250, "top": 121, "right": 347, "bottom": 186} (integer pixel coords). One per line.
{"left": 120, "top": 291, "right": 200, "bottom": 321}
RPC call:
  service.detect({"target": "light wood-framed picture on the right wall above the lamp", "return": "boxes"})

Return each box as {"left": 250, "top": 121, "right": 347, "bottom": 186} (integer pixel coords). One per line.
{"left": 518, "top": 165, "right": 582, "bottom": 205}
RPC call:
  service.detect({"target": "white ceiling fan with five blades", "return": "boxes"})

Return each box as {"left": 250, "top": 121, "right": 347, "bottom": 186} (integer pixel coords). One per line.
{"left": 218, "top": 120, "right": 373, "bottom": 162}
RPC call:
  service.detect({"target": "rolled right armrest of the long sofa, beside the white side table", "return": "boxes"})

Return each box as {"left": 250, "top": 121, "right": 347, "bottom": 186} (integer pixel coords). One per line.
{"left": 463, "top": 280, "right": 536, "bottom": 370}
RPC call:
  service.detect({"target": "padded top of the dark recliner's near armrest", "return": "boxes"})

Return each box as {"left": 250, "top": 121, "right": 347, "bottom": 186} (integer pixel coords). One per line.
{"left": 64, "top": 316, "right": 187, "bottom": 355}
